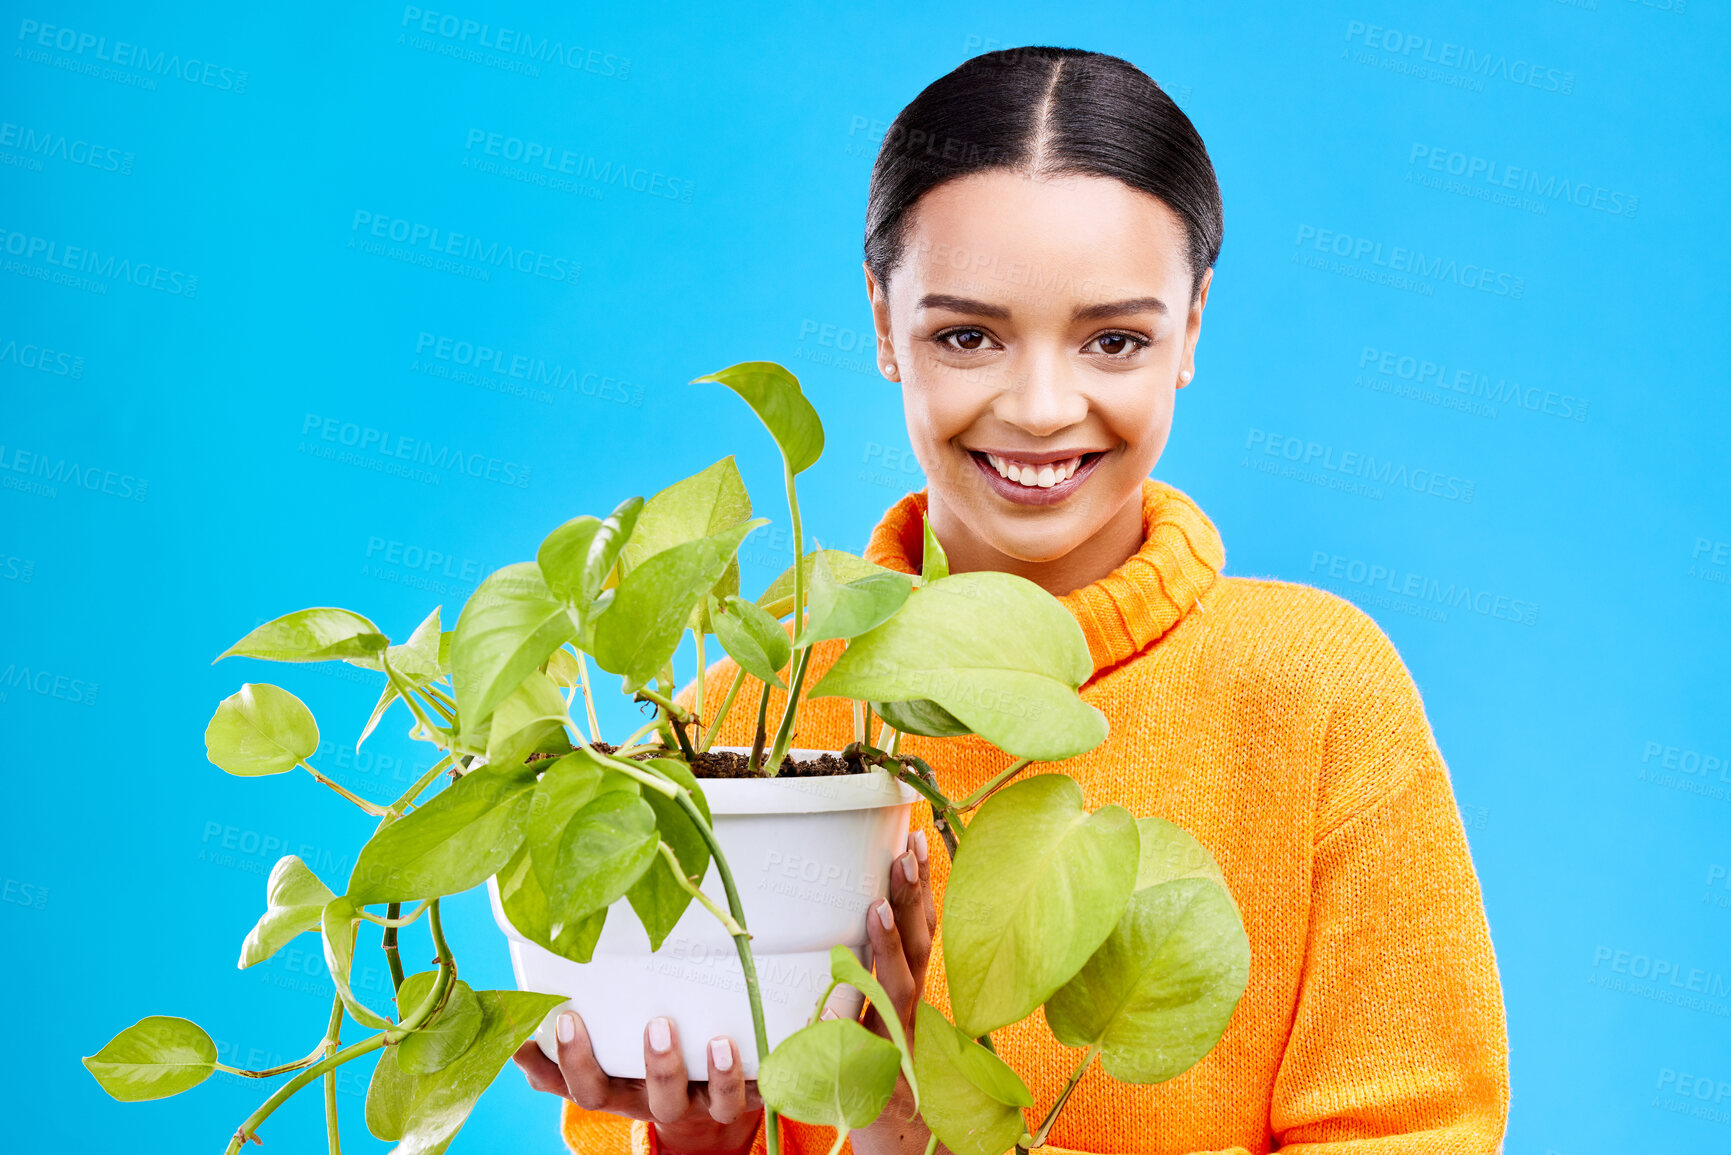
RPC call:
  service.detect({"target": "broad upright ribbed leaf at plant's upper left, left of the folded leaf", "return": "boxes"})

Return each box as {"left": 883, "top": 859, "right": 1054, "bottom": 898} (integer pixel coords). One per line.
{"left": 450, "top": 561, "right": 576, "bottom": 731}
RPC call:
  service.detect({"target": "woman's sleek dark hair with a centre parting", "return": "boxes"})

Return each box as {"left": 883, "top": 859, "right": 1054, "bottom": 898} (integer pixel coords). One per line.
{"left": 866, "top": 45, "right": 1224, "bottom": 300}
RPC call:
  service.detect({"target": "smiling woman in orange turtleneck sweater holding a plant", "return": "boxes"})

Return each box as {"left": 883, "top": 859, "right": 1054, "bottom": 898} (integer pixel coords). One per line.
{"left": 540, "top": 47, "right": 1509, "bottom": 1155}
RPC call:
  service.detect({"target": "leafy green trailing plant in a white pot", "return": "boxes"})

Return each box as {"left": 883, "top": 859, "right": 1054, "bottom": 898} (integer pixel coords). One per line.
{"left": 85, "top": 362, "right": 1248, "bottom": 1155}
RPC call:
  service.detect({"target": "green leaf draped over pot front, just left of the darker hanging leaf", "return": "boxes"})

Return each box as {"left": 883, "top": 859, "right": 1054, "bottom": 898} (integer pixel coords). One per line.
{"left": 547, "top": 783, "right": 660, "bottom": 923}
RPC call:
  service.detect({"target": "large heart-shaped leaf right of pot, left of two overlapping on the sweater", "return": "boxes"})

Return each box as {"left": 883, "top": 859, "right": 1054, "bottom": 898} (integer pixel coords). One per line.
{"left": 943, "top": 774, "right": 1141, "bottom": 1037}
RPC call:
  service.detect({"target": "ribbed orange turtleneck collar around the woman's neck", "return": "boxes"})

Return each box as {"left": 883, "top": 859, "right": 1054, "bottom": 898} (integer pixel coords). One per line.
{"left": 866, "top": 478, "right": 1226, "bottom": 672}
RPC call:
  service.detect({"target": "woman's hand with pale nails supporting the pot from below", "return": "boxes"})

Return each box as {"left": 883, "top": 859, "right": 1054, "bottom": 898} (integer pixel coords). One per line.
{"left": 514, "top": 1011, "right": 763, "bottom": 1155}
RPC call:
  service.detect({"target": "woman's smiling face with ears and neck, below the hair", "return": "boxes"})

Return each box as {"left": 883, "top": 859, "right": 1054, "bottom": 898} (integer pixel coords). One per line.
{"left": 866, "top": 170, "right": 1212, "bottom": 592}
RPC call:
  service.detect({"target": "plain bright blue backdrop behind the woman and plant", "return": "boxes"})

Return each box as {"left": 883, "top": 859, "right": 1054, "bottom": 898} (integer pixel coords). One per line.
{"left": 0, "top": 0, "right": 1731, "bottom": 1155}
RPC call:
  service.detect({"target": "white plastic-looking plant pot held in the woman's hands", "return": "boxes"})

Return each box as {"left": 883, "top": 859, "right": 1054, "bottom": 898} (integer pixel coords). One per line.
{"left": 486, "top": 746, "right": 919, "bottom": 1081}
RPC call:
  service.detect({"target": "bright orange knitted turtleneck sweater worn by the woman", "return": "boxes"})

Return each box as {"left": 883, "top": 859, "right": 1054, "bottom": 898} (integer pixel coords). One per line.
{"left": 564, "top": 480, "right": 1509, "bottom": 1155}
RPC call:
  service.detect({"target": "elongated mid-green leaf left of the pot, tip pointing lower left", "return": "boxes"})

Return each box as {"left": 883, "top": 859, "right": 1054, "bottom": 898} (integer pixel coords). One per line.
{"left": 348, "top": 764, "right": 535, "bottom": 906}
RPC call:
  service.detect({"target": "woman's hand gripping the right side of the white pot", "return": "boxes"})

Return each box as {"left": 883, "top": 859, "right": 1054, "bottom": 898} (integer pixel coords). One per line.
{"left": 850, "top": 829, "right": 942, "bottom": 1155}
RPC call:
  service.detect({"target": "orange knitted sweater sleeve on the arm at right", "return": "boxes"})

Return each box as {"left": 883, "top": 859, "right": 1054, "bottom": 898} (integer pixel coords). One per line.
{"left": 1269, "top": 611, "right": 1509, "bottom": 1155}
